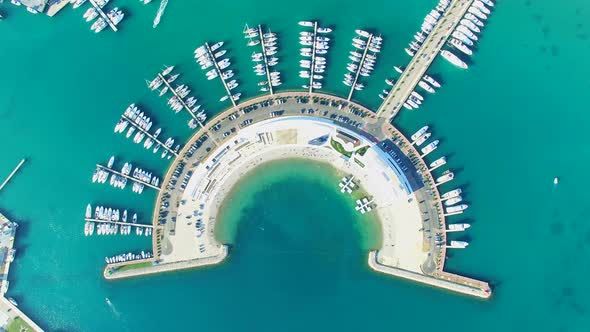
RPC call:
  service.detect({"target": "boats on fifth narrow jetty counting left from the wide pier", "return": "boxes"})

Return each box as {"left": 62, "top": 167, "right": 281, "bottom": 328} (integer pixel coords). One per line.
{"left": 146, "top": 66, "right": 207, "bottom": 129}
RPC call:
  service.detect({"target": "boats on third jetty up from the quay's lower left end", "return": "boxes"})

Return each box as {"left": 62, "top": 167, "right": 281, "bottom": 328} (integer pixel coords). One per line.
{"left": 115, "top": 104, "right": 180, "bottom": 159}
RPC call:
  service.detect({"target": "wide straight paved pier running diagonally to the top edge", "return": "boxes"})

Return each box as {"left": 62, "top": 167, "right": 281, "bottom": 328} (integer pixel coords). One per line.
{"left": 377, "top": 0, "right": 473, "bottom": 121}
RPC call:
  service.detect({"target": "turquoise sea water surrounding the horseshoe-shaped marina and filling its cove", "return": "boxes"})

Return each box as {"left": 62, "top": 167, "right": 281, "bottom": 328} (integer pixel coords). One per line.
{"left": 0, "top": 0, "right": 590, "bottom": 331}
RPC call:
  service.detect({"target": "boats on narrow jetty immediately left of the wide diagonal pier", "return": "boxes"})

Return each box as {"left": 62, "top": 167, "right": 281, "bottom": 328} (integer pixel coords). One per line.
{"left": 342, "top": 29, "right": 383, "bottom": 91}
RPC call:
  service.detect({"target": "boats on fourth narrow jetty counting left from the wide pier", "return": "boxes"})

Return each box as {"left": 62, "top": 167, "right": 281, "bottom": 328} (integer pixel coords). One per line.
{"left": 195, "top": 42, "right": 242, "bottom": 103}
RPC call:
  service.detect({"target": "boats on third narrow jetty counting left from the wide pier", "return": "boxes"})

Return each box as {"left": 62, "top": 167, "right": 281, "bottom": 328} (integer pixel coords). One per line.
{"left": 243, "top": 24, "right": 282, "bottom": 92}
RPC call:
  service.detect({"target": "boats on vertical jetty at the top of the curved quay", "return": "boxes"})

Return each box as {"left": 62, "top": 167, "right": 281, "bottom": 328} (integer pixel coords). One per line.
{"left": 299, "top": 21, "right": 332, "bottom": 90}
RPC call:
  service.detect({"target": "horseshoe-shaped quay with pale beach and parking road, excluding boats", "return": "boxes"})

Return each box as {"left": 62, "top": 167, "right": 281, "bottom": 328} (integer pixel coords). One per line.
{"left": 104, "top": 92, "right": 491, "bottom": 298}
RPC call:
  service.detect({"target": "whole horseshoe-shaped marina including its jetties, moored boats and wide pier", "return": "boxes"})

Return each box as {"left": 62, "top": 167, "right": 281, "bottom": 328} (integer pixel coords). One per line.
{"left": 96, "top": 0, "right": 500, "bottom": 298}
